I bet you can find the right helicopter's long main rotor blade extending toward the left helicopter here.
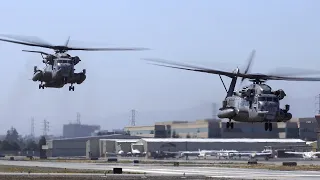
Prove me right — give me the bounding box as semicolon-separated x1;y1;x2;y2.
143;58;235;77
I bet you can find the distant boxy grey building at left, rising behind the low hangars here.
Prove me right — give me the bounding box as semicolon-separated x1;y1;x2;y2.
63;124;100;138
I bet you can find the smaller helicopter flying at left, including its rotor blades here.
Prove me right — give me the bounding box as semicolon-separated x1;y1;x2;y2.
0;34;147;91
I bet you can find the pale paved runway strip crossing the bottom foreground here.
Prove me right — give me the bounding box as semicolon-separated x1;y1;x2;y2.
0;160;320;180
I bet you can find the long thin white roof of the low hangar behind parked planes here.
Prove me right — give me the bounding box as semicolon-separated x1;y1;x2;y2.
142;138;305;143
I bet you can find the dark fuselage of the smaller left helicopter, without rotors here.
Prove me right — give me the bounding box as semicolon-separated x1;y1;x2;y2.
32;54;86;88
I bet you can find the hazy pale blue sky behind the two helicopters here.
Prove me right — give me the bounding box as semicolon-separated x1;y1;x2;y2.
0;0;320;135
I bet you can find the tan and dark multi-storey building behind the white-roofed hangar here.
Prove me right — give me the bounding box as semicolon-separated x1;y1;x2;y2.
125;117;317;141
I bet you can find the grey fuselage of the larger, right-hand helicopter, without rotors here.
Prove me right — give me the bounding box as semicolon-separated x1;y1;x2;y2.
218;84;292;123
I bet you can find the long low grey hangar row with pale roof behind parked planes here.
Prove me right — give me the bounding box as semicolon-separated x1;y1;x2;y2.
47;135;312;158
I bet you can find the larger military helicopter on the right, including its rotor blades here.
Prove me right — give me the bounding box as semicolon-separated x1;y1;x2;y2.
143;50;320;131
